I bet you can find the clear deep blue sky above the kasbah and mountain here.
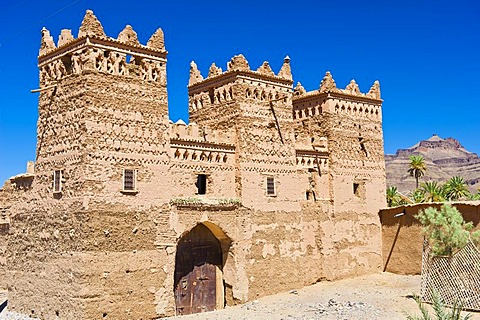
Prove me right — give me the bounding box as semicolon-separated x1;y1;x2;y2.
0;0;480;184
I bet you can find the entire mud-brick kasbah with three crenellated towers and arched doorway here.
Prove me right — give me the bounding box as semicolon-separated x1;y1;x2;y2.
0;10;385;319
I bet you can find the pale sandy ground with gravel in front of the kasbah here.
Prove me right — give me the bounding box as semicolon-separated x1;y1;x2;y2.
160;273;480;320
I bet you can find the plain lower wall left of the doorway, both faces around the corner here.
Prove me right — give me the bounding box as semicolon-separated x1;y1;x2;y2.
2;193;166;319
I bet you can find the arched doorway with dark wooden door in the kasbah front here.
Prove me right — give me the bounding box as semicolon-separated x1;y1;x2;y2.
174;224;230;315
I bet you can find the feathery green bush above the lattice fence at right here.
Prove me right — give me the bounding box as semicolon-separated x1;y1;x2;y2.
415;204;480;256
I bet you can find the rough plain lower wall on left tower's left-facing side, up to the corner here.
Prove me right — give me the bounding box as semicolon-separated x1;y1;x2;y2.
6;192;83;318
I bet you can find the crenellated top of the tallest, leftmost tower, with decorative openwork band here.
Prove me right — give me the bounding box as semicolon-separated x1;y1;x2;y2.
38;10;167;88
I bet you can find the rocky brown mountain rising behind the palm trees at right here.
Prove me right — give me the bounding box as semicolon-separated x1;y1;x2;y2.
385;134;480;193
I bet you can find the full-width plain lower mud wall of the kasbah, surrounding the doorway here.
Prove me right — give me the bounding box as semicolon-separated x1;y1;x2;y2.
1;186;380;319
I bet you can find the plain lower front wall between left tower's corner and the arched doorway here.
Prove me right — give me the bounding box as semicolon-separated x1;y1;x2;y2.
79;201;173;319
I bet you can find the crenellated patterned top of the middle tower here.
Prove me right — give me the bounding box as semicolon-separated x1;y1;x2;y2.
188;54;293;129
